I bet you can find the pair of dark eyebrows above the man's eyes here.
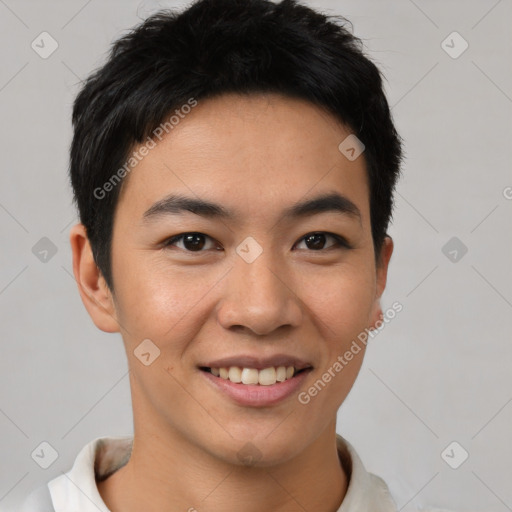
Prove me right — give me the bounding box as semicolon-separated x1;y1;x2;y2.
143;192;362;224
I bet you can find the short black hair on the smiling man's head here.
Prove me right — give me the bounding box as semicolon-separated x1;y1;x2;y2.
69;0;402;290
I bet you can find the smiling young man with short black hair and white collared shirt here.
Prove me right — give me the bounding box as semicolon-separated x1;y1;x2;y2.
20;0;402;512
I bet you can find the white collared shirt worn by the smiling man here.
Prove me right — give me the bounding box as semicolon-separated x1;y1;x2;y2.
19;435;397;512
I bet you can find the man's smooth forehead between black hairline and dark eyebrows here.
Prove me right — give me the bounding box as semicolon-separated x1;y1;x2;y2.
118;94;369;224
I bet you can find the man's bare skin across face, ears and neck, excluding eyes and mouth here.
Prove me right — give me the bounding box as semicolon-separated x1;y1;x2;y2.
70;94;393;512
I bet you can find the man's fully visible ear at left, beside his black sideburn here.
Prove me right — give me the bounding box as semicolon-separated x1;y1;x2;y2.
69;224;119;332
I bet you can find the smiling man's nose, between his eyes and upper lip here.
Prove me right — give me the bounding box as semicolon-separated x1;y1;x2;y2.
217;251;303;336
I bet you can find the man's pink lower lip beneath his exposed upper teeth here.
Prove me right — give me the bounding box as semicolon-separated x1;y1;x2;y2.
199;369;311;407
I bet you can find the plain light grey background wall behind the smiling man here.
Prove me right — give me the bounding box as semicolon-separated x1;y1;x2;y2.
0;0;512;512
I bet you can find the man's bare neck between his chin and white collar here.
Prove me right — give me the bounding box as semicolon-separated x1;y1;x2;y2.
98;408;348;512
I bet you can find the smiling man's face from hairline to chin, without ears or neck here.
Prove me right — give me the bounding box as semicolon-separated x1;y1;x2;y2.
80;95;391;464
